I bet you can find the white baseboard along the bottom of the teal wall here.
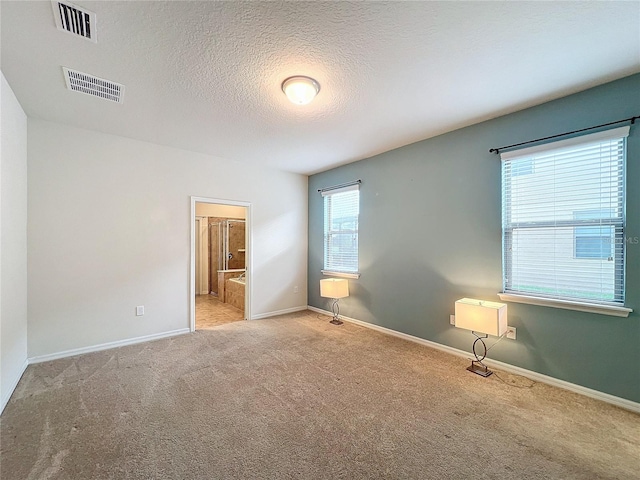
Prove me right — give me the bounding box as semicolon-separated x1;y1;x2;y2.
309;306;640;413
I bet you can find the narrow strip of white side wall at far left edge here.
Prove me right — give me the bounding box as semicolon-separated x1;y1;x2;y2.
0;74;27;412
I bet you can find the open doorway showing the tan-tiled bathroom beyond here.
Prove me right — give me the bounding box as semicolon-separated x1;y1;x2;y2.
190;197;251;331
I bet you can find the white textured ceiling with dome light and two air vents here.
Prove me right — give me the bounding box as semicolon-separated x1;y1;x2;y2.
0;0;640;174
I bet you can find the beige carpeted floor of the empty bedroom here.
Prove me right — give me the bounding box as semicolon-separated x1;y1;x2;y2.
0;312;640;480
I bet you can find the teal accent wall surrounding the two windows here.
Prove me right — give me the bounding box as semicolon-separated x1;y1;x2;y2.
308;74;640;402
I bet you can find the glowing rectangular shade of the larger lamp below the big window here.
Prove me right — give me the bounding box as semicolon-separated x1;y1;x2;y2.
456;298;507;337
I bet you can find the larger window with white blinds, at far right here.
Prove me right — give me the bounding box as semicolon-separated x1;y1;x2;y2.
501;127;629;305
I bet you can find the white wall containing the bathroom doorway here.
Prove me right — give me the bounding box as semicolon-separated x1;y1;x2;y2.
28;119;307;357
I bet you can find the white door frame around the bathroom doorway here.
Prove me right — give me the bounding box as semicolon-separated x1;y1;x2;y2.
189;196;253;332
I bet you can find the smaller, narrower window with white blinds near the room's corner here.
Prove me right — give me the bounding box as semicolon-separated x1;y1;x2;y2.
321;184;360;275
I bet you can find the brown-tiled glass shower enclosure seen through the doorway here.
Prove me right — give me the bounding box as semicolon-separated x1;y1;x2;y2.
209;217;246;295
